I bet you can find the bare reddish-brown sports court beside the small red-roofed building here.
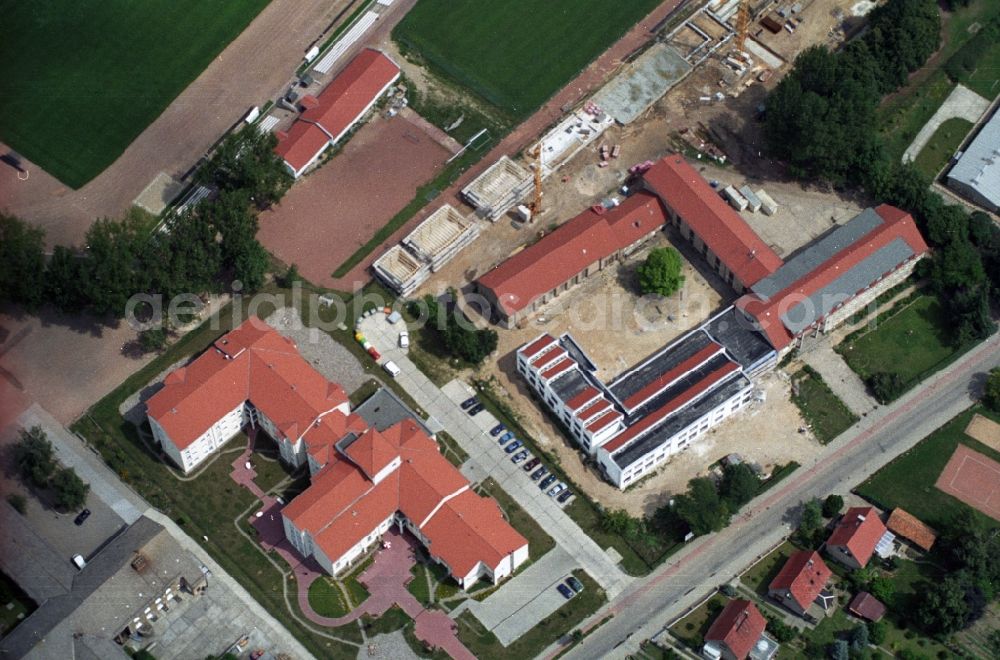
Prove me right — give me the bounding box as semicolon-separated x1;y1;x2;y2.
257;116;451;287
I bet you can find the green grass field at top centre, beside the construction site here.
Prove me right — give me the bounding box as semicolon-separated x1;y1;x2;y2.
393;0;660;118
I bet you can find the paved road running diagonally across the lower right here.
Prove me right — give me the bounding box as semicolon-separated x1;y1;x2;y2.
556;335;1000;658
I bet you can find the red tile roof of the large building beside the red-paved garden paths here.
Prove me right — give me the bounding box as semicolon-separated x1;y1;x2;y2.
282;420;527;577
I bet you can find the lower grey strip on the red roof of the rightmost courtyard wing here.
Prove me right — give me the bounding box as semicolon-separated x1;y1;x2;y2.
781;238;914;335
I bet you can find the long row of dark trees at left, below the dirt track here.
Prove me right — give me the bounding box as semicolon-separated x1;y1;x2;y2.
0;129;292;318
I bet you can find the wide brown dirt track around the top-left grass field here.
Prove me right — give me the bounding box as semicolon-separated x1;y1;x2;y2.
0;0;360;247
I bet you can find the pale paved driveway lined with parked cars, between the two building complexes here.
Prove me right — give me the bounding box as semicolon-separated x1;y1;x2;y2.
361;314;632;598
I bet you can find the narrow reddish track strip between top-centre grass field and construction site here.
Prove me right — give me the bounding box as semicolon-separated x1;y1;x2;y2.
329;0;688;291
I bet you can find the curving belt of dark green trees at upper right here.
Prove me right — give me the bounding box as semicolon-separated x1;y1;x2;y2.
764;0;1000;348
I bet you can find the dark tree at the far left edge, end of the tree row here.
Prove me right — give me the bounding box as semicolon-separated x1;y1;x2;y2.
0;213;45;310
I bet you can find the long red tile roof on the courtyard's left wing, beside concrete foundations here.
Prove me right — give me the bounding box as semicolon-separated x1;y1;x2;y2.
479;193;666;314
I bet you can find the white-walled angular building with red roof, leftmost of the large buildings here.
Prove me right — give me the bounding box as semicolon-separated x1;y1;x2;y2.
146;318;356;473
